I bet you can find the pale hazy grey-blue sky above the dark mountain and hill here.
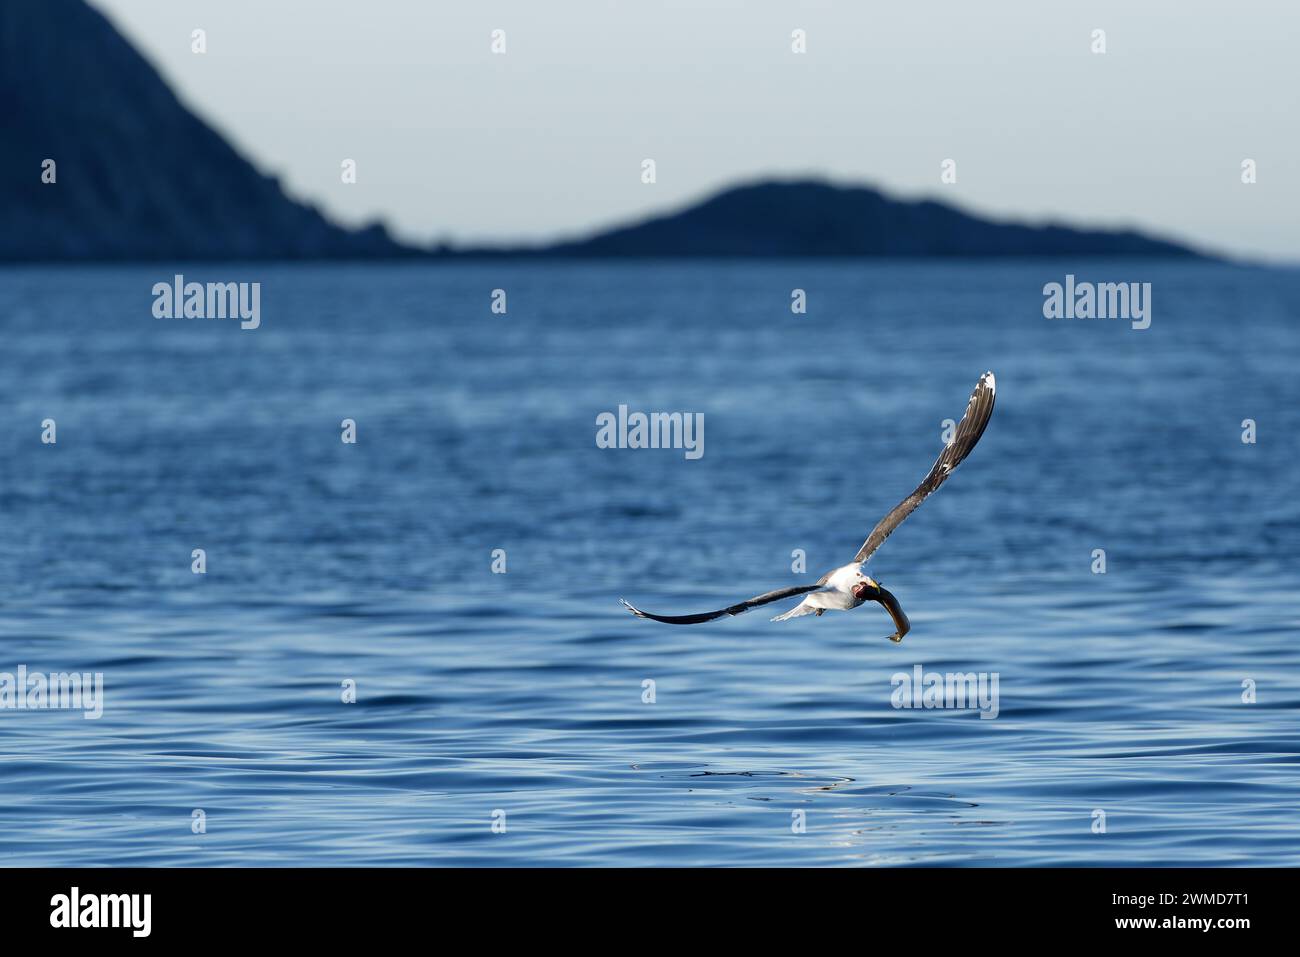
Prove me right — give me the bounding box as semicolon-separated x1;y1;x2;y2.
94;0;1300;260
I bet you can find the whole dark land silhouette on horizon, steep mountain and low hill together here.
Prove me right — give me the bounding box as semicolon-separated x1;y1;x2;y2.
0;0;1204;263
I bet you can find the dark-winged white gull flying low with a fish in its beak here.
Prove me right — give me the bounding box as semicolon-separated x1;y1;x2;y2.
619;372;997;641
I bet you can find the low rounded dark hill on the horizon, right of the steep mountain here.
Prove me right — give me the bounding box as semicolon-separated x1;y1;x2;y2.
483;181;1201;259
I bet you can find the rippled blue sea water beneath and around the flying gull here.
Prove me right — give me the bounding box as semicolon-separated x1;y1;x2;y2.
0;261;1300;866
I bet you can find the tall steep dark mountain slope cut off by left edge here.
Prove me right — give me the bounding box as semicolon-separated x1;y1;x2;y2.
0;0;408;260
